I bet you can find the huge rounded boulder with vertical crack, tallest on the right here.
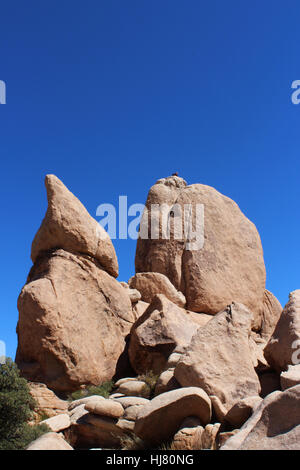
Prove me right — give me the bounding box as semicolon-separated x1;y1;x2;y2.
135;176;266;330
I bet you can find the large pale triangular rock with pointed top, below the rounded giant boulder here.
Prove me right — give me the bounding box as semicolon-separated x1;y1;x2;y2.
175;302;260;414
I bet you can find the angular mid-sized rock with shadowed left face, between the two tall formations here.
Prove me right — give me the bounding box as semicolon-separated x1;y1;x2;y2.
128;294;209;374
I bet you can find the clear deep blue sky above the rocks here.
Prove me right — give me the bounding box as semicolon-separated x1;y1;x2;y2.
0;0;300;357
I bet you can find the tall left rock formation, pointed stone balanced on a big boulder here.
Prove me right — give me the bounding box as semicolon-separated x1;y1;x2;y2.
16;176;135;392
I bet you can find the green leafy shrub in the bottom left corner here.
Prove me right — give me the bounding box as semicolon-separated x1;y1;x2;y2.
0;359;50;450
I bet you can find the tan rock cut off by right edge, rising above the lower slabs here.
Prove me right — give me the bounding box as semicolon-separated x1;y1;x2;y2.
264;289;300;372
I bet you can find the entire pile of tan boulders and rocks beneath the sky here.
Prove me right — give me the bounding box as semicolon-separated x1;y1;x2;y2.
16;176;300;449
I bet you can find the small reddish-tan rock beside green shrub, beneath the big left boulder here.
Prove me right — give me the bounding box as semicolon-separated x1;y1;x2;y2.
28;382;68;420
